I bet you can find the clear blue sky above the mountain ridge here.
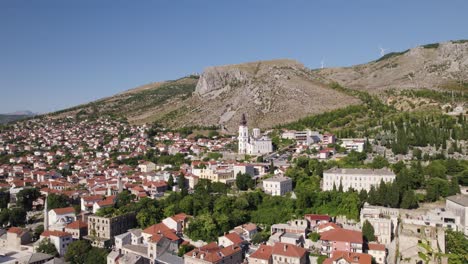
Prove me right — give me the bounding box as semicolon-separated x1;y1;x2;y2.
0;0;468;113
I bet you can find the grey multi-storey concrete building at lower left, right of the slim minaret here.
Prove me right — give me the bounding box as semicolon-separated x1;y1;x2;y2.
86;212;136;247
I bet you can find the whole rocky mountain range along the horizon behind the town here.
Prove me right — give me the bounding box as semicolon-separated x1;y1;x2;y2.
44;40;468;132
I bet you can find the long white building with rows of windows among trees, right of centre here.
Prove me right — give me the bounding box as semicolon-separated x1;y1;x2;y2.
322;168;396;192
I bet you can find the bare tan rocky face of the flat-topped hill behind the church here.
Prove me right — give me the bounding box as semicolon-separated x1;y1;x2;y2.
174;60;359;132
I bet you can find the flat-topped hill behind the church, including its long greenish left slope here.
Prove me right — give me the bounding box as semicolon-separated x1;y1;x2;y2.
49;60;360;132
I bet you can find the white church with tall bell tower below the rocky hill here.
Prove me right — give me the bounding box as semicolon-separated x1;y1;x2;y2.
238;114;273;155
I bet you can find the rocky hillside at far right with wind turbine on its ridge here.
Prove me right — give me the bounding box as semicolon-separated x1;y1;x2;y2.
317;40;468;94
